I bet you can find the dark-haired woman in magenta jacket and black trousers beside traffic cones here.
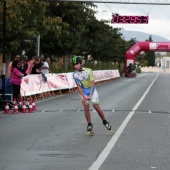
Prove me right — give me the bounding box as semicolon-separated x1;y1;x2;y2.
11;61;24;101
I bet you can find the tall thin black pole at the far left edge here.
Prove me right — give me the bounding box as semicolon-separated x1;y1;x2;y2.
1;0;6;100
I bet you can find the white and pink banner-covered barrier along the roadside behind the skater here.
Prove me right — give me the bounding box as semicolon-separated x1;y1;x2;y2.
18;70;120;98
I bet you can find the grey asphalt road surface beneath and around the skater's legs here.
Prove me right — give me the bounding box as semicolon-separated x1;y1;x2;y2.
0;73;170;170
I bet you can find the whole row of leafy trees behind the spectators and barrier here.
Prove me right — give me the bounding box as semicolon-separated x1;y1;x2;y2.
0;0;135;69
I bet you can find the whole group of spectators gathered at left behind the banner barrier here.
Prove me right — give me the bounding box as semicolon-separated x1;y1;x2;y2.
7;54;51;101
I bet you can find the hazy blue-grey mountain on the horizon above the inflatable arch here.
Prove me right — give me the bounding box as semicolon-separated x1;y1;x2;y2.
120;30;170;42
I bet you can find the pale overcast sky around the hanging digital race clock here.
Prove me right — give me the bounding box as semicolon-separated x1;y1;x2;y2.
95;3;170;40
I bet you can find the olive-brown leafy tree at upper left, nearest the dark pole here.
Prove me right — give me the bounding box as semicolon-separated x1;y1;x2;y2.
0;0;62;53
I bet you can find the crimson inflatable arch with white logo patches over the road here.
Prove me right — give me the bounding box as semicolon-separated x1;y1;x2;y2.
125;42;170;75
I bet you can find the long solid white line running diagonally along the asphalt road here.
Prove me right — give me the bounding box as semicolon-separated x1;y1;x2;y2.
88;74;159;170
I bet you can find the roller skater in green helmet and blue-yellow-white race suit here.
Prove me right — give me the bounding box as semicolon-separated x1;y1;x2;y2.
72;56;113;136
